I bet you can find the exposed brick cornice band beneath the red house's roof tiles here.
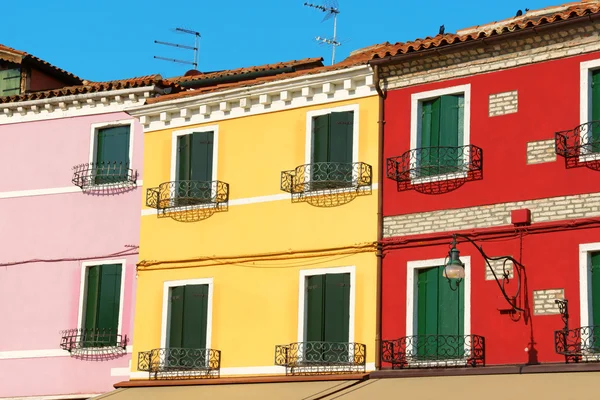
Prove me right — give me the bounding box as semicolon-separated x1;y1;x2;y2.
382;21;600;89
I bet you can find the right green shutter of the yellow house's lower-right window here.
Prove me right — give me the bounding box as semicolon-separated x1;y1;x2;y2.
323;274;350;343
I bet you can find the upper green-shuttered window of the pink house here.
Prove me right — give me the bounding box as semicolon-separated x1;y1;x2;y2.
91;121;133;185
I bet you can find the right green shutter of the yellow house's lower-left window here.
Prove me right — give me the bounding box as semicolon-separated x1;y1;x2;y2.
181;285;208;349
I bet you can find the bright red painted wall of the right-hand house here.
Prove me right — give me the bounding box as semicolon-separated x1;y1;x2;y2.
382;52;600;367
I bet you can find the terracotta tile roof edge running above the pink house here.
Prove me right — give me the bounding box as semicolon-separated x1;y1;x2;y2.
0;75;181;104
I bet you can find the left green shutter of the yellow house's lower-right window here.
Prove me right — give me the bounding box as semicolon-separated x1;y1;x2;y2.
306;275;325;342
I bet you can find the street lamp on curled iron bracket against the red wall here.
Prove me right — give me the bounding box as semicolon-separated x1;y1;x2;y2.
443;233;525;312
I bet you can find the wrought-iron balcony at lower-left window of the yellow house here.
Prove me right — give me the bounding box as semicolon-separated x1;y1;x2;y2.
138;347;221;379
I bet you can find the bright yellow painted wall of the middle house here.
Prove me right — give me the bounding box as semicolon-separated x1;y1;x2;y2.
132;97;378;375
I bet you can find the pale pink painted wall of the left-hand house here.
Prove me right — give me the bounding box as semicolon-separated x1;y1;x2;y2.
0;113;143;398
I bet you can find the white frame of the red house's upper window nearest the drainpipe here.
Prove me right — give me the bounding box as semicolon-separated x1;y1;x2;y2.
410;83;471;185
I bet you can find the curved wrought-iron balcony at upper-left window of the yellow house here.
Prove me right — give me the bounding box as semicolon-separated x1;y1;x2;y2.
146;181;229;222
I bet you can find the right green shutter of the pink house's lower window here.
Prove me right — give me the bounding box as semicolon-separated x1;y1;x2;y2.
96;264;121;334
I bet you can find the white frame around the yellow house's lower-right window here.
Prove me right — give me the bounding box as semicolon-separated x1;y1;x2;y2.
296;265;356;344
